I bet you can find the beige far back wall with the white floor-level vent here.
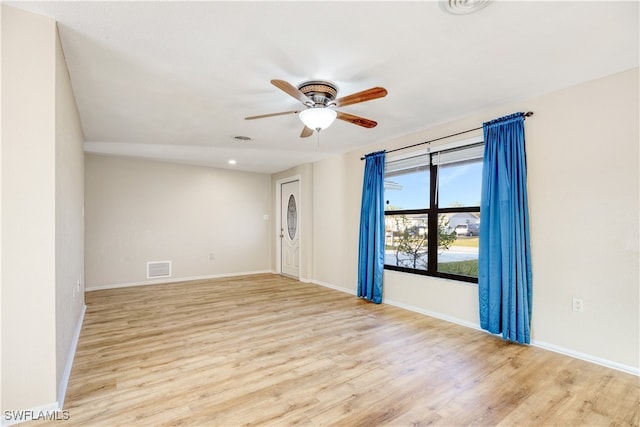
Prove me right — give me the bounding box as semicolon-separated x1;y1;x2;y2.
85;154;272;289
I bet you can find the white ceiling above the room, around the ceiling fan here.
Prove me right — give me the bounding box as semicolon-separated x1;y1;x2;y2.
5;1;639;173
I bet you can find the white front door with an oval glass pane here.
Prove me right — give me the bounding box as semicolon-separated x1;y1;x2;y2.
280;181;300;278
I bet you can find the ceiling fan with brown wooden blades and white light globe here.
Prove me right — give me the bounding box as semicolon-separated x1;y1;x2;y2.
245;79;387;138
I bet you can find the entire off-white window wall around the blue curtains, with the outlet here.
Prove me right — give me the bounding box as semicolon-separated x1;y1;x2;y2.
313;69;640;373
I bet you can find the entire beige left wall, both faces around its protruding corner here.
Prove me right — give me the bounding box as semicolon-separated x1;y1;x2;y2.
1;5;83;410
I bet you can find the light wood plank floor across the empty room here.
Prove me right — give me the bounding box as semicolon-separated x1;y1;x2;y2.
34;274;640;426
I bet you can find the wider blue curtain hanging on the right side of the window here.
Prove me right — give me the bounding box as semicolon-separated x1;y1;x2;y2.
478;113;531;344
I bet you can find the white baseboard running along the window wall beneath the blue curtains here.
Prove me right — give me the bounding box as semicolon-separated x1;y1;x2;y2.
309;280;640;376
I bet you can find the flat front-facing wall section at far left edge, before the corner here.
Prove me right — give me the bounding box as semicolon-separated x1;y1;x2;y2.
2;5;56;410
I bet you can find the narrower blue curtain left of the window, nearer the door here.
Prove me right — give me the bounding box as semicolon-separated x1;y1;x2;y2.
358;151;385;304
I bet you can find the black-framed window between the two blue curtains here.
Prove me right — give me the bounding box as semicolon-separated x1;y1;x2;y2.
384;140;483;283
